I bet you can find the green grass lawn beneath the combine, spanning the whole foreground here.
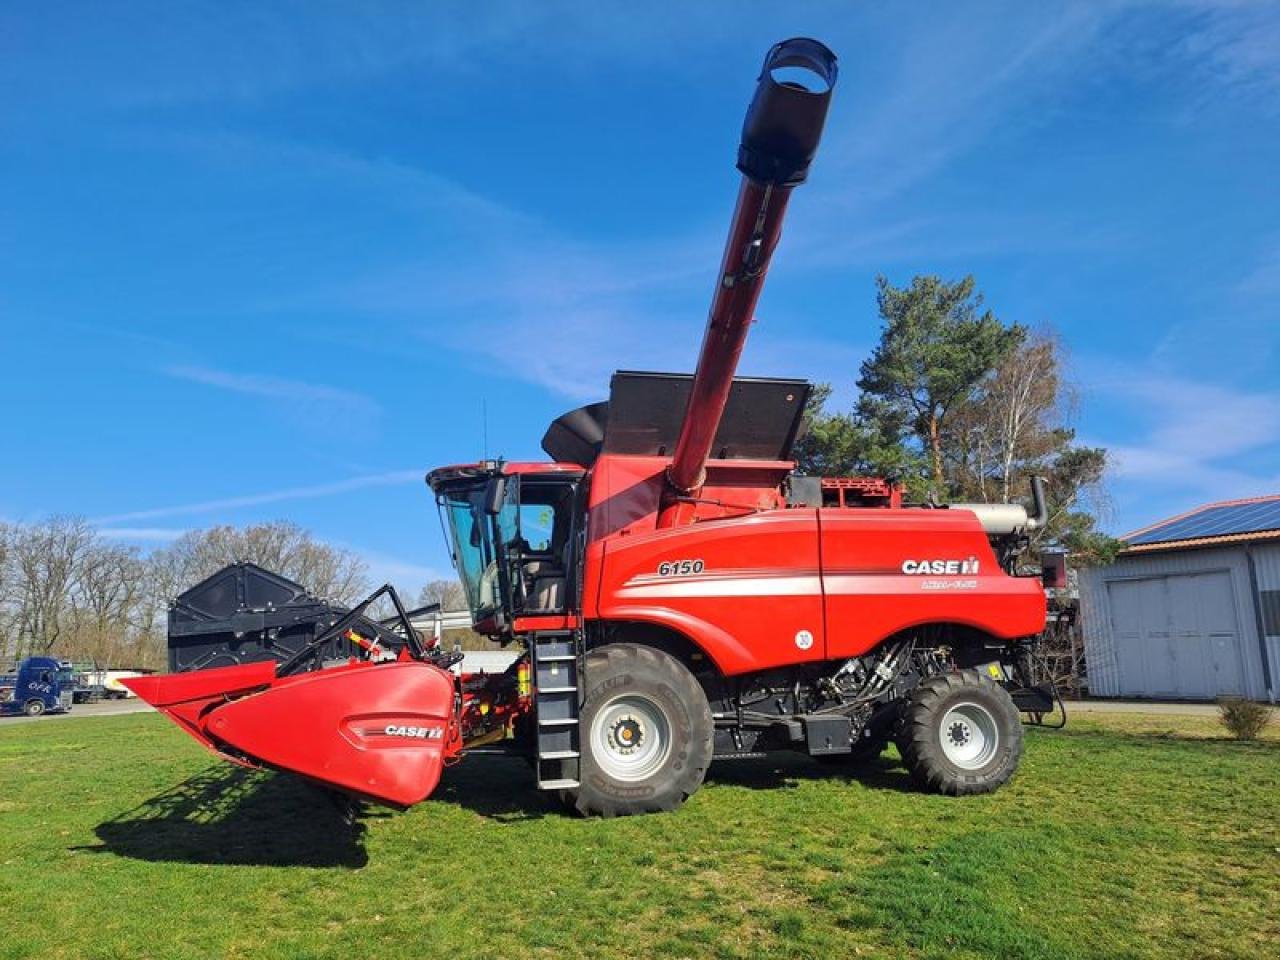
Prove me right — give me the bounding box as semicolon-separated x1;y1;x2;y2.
0;714;1280;960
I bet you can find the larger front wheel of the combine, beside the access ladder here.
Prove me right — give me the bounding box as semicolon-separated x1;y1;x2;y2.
561;644;716;817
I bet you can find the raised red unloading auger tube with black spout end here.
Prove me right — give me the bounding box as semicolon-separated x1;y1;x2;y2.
658;37;837;527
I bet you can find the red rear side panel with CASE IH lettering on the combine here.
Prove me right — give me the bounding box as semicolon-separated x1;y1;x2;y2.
818;509;1044;659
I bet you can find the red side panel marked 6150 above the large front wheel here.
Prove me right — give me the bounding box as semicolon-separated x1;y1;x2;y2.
593;509;827;675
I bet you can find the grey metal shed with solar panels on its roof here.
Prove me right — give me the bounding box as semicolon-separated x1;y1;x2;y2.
1080;494;1280;703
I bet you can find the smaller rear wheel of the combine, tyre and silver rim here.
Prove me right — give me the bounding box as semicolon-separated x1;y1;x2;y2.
896;669;1023;796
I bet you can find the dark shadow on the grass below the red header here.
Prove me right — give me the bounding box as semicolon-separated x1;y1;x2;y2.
78;763;378;869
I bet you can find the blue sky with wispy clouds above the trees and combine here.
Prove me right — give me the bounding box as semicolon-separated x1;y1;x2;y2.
0;0;1280;586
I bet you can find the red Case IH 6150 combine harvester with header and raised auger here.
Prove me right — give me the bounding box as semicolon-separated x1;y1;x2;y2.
125;38;1052;817
